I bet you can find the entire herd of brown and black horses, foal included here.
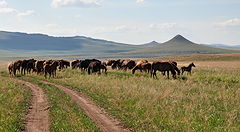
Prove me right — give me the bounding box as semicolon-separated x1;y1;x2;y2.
8;59;195;79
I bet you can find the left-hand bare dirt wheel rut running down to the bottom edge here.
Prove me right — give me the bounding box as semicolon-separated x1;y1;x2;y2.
16;79;49;132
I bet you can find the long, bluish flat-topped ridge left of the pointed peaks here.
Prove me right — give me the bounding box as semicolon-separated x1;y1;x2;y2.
0;31;157;55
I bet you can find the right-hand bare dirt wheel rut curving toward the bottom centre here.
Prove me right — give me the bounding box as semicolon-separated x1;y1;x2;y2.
42;81;129;132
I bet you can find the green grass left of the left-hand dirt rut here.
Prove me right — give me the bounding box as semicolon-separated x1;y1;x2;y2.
0;75;31;132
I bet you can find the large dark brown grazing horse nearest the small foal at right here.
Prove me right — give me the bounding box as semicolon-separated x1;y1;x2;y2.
151;62;176;79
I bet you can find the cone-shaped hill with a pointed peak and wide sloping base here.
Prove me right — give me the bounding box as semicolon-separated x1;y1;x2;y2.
120;35;238;57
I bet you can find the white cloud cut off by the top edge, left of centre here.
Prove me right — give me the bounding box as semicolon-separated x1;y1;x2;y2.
52;0;100;8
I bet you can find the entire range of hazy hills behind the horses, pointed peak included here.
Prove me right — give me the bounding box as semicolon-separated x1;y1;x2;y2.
0;31;236;57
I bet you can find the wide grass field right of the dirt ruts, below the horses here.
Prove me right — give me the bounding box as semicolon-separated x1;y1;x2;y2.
0;54;240;132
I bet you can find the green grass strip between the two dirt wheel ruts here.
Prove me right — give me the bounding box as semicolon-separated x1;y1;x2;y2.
18;77;100;132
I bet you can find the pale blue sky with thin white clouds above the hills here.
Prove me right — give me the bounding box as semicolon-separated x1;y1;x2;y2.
0;0;240;45
